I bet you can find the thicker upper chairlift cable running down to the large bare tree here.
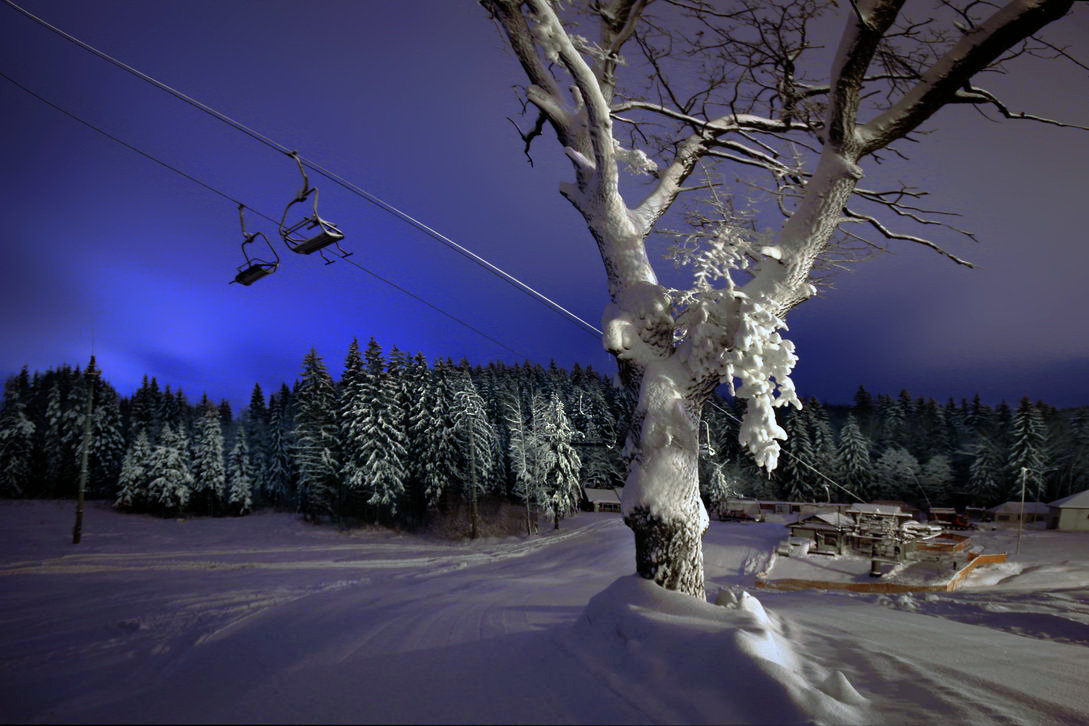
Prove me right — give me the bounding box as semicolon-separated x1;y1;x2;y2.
2;0;602;335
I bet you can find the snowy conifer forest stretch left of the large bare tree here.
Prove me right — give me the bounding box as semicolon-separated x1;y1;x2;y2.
0;340;632;533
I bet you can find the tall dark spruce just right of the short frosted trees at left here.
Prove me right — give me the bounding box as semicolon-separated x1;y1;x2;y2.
294;348;340;521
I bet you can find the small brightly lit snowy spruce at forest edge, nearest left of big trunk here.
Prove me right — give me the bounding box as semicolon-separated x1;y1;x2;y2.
536;392;583;529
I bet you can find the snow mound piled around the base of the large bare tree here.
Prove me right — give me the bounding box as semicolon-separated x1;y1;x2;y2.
566;575;872;724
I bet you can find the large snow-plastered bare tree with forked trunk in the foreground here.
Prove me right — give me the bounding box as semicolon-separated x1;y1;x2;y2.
482;0;1072;598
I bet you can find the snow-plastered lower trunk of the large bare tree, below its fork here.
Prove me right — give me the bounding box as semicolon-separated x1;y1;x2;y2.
623;364;709;599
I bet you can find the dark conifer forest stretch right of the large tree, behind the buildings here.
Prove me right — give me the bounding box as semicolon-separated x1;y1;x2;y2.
701;386;1089;507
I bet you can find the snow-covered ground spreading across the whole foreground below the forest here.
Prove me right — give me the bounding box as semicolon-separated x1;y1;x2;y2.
0;502;1089;724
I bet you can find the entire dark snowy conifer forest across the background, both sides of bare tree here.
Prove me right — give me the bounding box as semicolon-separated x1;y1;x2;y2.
0;340;1089;533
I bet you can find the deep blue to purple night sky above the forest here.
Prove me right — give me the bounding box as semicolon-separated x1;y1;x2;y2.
0;0;1089;407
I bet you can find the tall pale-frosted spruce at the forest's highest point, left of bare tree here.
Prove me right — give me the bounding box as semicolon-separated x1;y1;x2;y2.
355;339;407;521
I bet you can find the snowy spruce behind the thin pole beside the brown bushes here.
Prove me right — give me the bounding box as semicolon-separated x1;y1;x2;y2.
452;373;495;539
